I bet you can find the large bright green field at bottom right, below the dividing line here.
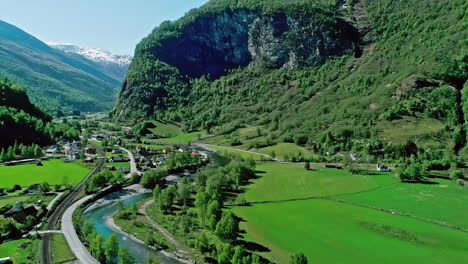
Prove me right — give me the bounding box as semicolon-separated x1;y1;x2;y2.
234;200;468;264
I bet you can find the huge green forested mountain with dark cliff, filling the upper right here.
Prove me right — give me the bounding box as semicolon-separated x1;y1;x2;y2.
112;0;468;157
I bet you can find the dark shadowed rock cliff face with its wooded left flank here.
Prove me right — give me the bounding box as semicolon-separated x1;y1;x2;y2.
114;5;359;120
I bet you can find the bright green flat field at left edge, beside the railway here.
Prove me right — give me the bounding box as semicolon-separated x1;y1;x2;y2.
0;159;90;188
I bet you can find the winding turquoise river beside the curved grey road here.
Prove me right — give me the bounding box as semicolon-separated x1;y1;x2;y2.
85;189;182;264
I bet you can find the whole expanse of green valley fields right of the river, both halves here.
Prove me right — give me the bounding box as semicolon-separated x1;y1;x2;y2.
232;163;468;263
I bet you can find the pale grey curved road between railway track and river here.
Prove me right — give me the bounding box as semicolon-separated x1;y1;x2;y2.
59;145;139;264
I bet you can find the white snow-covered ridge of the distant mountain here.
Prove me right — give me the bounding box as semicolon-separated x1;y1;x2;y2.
47;43;132;66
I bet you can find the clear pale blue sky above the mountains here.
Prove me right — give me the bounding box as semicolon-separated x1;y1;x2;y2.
0;0;208;56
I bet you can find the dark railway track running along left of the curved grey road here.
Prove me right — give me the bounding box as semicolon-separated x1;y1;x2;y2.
39;145;105;264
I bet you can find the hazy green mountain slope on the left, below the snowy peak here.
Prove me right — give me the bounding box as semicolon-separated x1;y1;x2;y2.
0;21;122;111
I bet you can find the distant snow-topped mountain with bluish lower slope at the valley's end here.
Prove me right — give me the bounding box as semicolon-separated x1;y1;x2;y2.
47;43;132;80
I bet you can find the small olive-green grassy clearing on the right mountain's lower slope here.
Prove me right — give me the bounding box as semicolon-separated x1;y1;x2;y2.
376;117;444;144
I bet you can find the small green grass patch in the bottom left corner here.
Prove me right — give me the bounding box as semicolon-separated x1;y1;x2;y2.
0;239;39;264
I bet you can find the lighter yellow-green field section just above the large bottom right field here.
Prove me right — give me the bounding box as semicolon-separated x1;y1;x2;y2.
245;162;397;202
